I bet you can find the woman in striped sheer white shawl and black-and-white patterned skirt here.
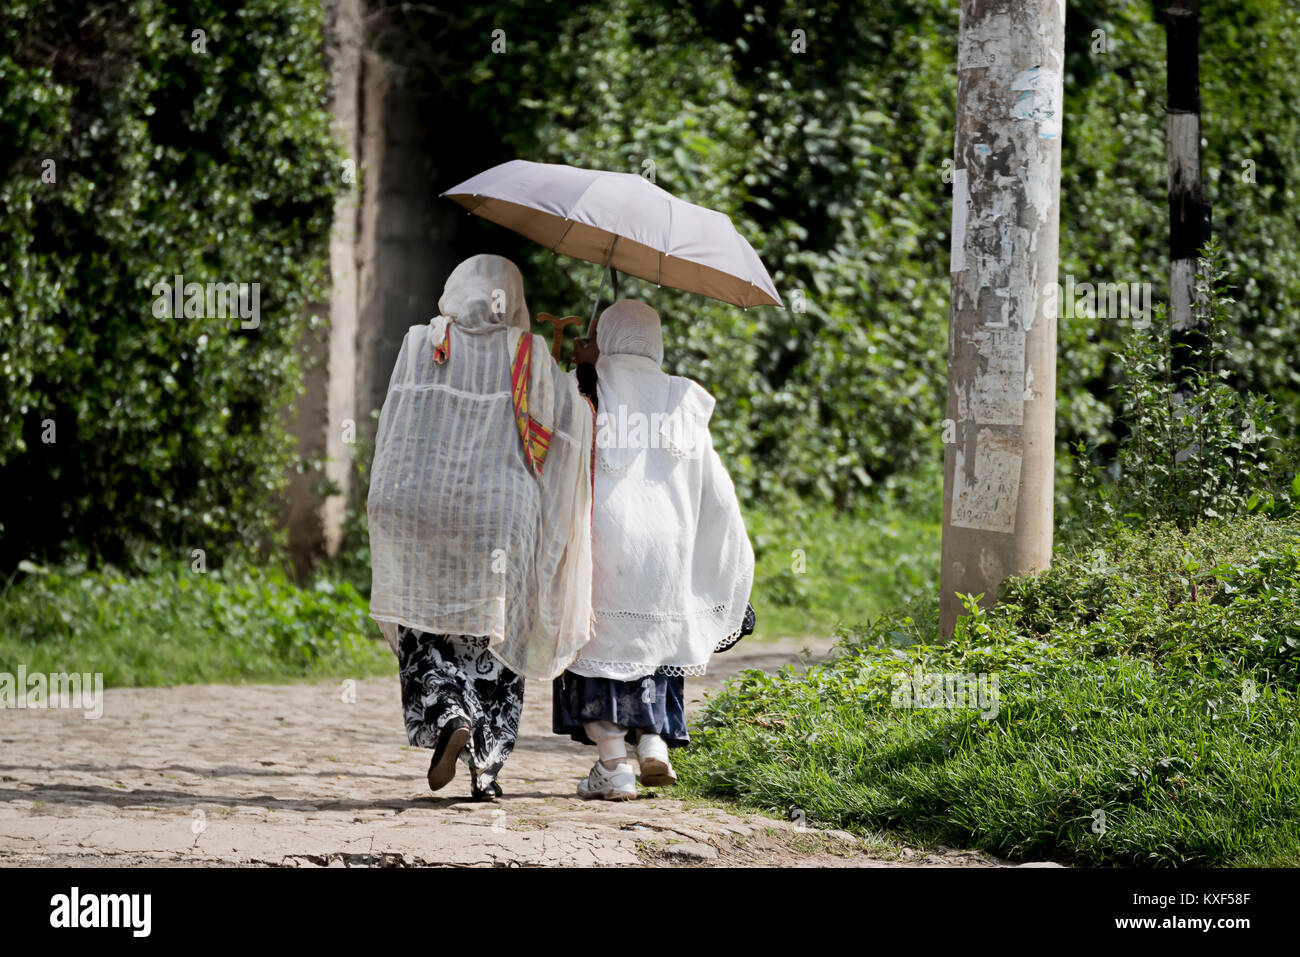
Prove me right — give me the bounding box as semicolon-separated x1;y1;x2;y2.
368;256;593;798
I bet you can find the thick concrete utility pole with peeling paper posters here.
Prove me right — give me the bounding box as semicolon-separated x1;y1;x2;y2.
940;0;1065;636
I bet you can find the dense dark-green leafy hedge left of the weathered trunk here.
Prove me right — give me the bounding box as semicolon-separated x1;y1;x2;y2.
0;0;342;568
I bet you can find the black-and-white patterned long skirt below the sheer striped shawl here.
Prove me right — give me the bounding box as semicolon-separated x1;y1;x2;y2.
398;627;524;791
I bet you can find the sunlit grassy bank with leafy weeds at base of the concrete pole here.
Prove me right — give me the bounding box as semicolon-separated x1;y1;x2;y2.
675;518;1300;866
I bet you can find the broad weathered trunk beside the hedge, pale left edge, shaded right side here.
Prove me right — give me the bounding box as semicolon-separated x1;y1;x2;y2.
286;0;464;572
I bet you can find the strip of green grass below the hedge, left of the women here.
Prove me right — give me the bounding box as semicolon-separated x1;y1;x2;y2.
0;558;393;685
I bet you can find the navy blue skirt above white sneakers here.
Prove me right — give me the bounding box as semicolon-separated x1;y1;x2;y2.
551;671;690;748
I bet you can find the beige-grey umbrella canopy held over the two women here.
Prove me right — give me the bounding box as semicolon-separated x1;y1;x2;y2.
442;160;781;308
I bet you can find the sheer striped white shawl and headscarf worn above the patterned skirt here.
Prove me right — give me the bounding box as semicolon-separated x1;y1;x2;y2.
368;256;593;679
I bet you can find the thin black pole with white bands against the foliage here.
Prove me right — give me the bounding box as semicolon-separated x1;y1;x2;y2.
1165;0;1210;385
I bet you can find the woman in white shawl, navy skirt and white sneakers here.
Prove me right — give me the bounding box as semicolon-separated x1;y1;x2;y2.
553;299;754;800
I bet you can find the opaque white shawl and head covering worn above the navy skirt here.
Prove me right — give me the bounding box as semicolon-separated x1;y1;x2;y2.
569;300;754;680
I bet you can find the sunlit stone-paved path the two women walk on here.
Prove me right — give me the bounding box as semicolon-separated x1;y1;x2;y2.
0;641;998;867
